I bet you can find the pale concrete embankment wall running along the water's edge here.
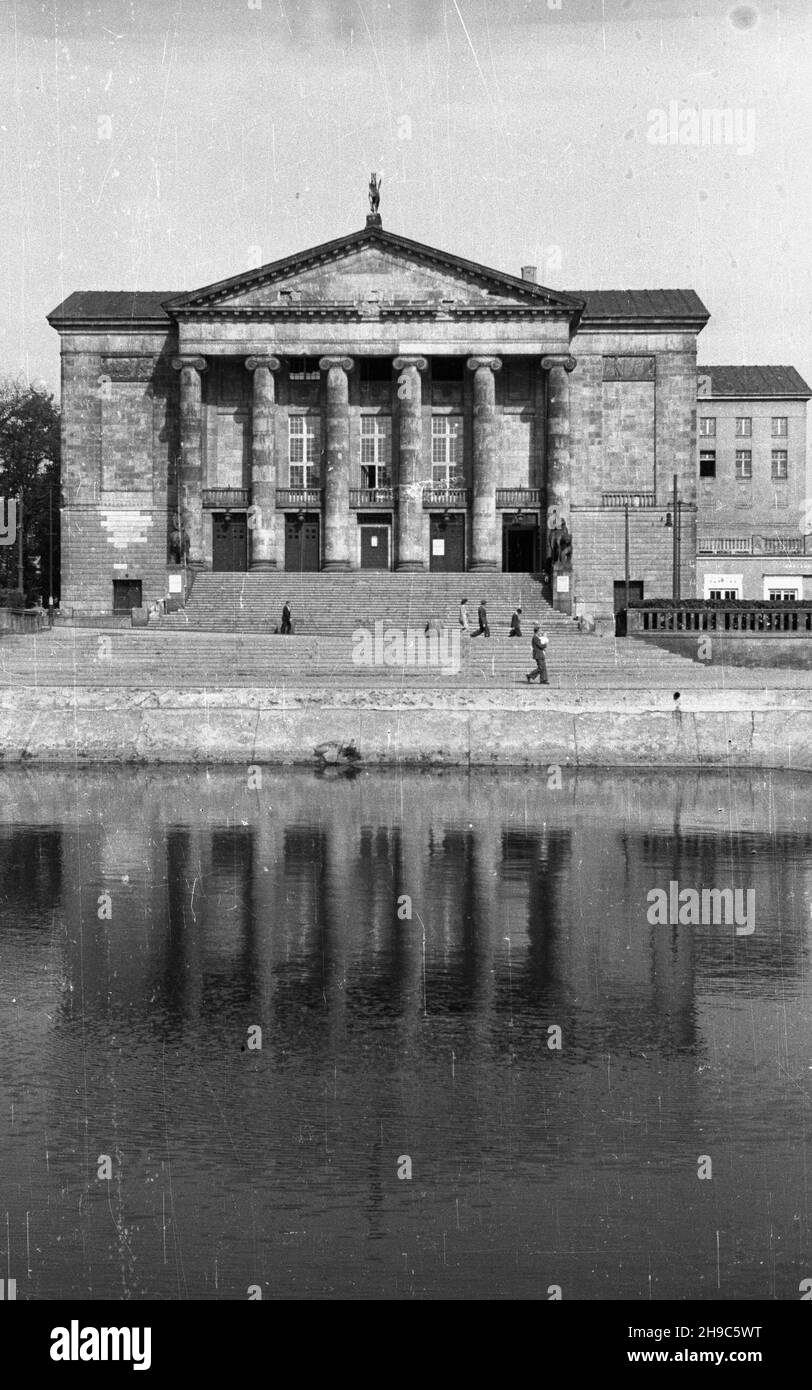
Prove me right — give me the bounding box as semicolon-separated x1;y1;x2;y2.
6;681;812;771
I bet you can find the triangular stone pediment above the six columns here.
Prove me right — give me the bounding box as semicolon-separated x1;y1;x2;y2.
165;227;583;318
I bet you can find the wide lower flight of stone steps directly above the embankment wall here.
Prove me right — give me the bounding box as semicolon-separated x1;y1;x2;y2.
0;623;784;692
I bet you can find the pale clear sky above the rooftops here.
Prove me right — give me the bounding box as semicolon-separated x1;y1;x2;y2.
0;0;812;403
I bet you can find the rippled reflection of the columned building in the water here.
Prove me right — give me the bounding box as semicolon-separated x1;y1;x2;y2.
0;771;812;1048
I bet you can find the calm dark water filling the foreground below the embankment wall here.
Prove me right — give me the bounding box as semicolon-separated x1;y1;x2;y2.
0;767;812;1300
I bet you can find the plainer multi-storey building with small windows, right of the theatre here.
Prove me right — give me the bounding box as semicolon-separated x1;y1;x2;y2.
697;367;812;599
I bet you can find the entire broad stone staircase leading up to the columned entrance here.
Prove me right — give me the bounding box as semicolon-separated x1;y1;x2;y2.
6;571;804;691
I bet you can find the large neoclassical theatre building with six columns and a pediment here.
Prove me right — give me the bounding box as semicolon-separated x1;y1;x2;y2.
49;213;709;614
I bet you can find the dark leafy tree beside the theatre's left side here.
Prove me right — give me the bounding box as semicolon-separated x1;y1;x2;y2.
0;378;61;605
